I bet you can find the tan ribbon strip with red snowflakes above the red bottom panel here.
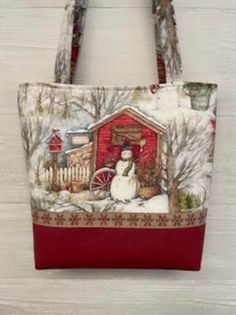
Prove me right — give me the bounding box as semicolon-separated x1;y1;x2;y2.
32;210;207;229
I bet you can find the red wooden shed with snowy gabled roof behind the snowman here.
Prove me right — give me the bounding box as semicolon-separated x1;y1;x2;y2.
89;106;165;171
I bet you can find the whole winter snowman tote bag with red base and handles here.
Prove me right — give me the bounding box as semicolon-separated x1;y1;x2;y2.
18;0;217;270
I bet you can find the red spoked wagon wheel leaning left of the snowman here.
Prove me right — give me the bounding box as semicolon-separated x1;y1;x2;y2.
89;167;116;199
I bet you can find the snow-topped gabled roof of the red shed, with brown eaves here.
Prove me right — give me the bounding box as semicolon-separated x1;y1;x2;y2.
88;106;166;135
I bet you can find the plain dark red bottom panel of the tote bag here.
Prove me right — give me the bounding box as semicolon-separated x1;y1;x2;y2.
33;224;205;270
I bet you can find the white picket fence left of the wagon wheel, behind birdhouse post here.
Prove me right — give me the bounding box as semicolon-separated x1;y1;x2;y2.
43;166;91;184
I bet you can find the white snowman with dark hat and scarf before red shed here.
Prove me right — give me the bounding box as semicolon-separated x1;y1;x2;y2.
111;146;138;202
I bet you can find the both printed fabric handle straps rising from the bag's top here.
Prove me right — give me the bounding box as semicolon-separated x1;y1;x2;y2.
55;0;182;84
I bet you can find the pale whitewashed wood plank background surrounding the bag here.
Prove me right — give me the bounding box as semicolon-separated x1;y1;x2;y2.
0;0;236;315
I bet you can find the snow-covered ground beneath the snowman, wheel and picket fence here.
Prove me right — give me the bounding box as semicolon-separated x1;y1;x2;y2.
32;189;169;213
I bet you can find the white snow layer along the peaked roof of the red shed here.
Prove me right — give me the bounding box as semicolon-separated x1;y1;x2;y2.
88;105;166;133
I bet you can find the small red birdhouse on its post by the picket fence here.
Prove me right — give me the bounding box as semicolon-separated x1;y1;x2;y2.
47;129;64;191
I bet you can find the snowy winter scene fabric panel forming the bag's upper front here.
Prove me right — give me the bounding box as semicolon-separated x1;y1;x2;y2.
19;84;216;213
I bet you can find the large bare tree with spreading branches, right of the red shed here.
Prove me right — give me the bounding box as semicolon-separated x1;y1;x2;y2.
163;113;211;212
